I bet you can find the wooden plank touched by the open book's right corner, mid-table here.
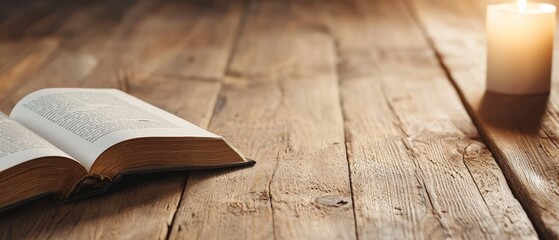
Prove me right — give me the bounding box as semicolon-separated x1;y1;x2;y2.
171;1;356;239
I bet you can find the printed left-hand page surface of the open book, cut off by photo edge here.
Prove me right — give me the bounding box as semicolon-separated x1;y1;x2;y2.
0;112;75;172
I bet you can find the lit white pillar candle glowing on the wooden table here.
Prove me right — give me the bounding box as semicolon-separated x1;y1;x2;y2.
486;1;555;94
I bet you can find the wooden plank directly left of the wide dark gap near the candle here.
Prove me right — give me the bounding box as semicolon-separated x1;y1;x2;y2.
324;0;537;239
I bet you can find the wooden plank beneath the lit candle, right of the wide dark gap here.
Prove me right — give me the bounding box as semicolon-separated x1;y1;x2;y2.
414;0;559;239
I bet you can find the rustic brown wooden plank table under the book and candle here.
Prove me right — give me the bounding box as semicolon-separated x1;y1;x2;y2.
0;0;559;239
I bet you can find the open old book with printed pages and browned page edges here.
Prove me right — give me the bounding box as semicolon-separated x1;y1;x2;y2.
0;88;254;209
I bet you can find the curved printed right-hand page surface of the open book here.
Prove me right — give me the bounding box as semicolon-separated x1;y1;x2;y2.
11;88;221;171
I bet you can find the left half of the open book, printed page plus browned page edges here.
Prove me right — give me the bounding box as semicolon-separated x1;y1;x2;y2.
0;113;87;211
